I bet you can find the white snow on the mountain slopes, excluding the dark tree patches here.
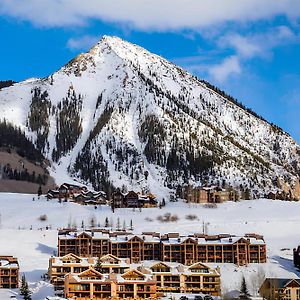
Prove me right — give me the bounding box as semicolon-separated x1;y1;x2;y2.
0;36;300;198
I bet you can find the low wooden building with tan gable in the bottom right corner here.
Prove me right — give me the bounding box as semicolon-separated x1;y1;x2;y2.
259;278;300;300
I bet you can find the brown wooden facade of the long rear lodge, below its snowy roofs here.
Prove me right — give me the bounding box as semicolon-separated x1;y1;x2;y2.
58;235;266;265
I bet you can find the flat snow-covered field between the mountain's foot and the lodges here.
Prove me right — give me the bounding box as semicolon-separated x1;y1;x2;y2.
0;193;300;300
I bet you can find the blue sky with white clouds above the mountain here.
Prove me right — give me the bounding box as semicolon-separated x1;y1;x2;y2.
0;0;300;142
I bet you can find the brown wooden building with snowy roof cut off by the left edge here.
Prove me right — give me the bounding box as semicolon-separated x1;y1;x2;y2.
0;256;19;289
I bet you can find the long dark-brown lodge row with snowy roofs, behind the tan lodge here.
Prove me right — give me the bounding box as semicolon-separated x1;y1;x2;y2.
58;230;266;265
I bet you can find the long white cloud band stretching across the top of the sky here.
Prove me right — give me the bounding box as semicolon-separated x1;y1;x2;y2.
0;0;300;31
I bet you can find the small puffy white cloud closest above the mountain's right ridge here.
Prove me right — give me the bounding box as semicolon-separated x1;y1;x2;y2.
208;56;241;82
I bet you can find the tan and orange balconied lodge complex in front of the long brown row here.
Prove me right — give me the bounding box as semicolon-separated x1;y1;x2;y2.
48;254;220;299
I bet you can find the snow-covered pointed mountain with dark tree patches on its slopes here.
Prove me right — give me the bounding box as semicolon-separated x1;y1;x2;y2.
0;36;300;198
